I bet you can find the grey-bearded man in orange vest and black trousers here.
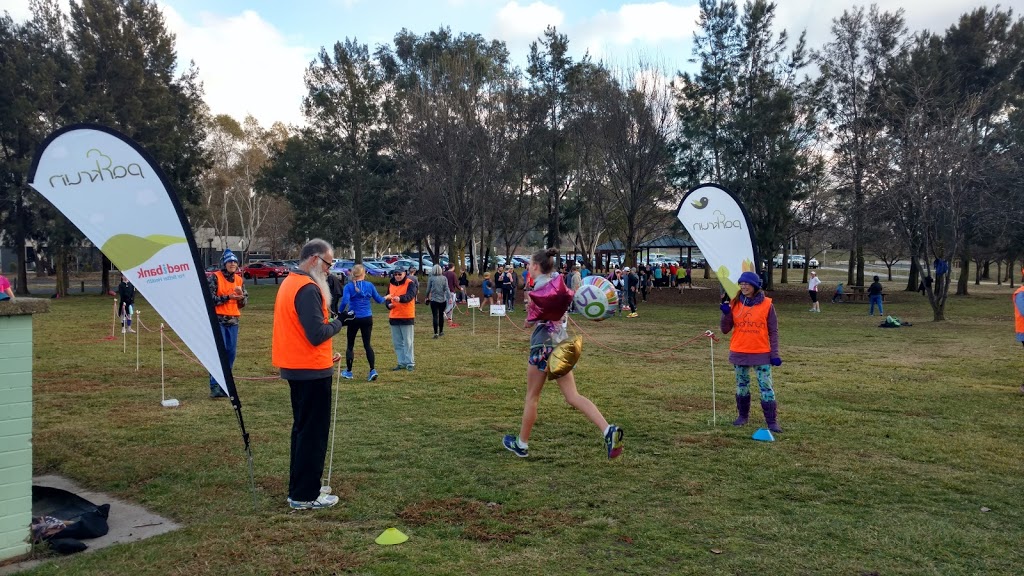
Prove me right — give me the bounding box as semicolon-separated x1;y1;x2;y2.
271;238;341;509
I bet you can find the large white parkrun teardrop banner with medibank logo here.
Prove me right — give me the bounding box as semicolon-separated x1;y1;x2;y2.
29;124;252;494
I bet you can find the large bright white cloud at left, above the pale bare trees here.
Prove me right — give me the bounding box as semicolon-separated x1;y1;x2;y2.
157;0;316;127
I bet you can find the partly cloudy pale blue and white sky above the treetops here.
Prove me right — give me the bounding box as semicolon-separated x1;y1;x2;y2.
0;0;991;126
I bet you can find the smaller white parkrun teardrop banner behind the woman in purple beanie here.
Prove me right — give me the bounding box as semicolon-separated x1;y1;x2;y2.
677;183;761;298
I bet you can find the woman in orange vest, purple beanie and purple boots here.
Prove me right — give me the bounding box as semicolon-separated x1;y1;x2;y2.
721;272;782;433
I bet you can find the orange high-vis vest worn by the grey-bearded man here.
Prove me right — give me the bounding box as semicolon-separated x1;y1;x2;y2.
270;274;334;370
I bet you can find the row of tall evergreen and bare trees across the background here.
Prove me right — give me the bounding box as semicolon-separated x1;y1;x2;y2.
0;0;1024;319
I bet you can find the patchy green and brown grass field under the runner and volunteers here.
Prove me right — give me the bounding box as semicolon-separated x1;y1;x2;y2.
16;281;1024;576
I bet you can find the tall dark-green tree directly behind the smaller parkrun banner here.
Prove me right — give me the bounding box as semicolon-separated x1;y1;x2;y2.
675;0;821;286
